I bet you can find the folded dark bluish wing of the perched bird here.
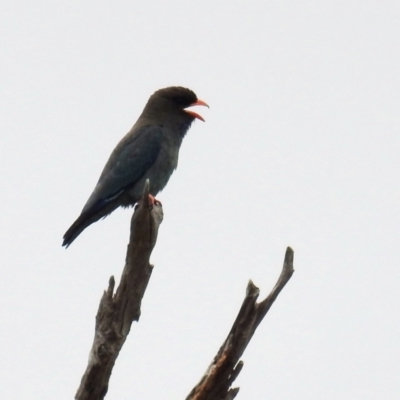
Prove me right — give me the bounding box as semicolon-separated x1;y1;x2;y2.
82;126;163;213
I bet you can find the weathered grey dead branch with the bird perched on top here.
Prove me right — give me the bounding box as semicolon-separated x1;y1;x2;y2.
75;180;163;400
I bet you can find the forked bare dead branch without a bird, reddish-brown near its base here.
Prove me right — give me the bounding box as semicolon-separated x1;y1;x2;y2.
186;247;294;400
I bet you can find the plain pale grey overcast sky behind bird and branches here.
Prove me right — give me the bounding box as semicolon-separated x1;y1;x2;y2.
0;0;400;400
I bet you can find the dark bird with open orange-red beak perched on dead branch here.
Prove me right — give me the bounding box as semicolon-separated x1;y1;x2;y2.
62;86;209;248
